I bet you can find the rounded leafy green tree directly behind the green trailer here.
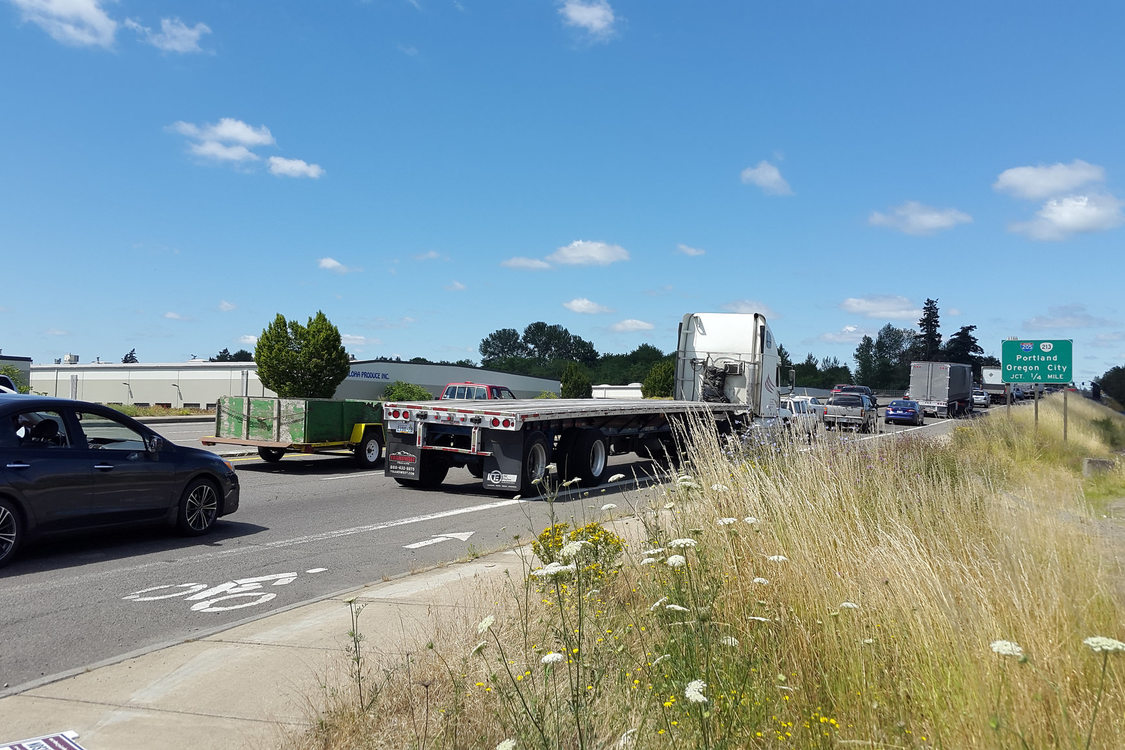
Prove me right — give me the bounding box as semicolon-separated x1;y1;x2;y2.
254;310;351;398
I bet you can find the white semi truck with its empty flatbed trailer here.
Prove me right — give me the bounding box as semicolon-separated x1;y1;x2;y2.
384;313;781;493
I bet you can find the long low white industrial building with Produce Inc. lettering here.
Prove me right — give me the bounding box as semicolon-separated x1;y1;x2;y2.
30;356;559;409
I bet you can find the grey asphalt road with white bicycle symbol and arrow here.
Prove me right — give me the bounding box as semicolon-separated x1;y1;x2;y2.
0;419;967;695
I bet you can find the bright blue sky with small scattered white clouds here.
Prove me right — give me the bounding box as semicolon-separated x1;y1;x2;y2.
0;0;1125;380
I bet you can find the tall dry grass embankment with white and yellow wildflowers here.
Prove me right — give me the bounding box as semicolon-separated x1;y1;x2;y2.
286;397;1125;750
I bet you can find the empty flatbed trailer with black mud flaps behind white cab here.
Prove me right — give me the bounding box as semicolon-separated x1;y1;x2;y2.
384;398;748;493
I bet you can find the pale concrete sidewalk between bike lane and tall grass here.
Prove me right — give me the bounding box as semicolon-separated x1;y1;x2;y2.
0;550;544;750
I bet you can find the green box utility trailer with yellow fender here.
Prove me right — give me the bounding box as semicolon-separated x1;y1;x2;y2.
200;396;384;469
